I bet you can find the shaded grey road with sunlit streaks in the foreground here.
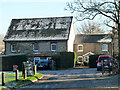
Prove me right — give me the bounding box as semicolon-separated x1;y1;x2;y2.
17;68;119;90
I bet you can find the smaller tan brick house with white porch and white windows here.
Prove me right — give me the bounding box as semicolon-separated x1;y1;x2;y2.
74;34;112;64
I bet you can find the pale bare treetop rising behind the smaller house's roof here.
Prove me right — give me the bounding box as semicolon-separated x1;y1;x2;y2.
78;21;104;34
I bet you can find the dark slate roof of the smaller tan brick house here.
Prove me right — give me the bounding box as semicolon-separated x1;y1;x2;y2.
74;34;112;44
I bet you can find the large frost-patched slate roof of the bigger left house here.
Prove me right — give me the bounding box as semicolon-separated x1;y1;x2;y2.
4;16;73;41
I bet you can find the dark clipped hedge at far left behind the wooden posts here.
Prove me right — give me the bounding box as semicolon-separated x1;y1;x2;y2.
0;54;27;71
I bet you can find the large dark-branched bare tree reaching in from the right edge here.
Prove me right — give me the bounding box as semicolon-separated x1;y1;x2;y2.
66;0;120;72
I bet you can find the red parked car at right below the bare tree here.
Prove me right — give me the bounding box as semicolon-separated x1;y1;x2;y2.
97;55;112;71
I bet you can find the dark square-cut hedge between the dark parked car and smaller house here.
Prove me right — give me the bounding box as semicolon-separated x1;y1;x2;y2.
52;52;75;69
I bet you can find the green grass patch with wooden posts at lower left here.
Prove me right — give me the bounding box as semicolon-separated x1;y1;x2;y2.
0;73;43;89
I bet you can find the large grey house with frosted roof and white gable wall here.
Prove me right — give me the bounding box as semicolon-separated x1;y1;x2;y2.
4;16;75;64
